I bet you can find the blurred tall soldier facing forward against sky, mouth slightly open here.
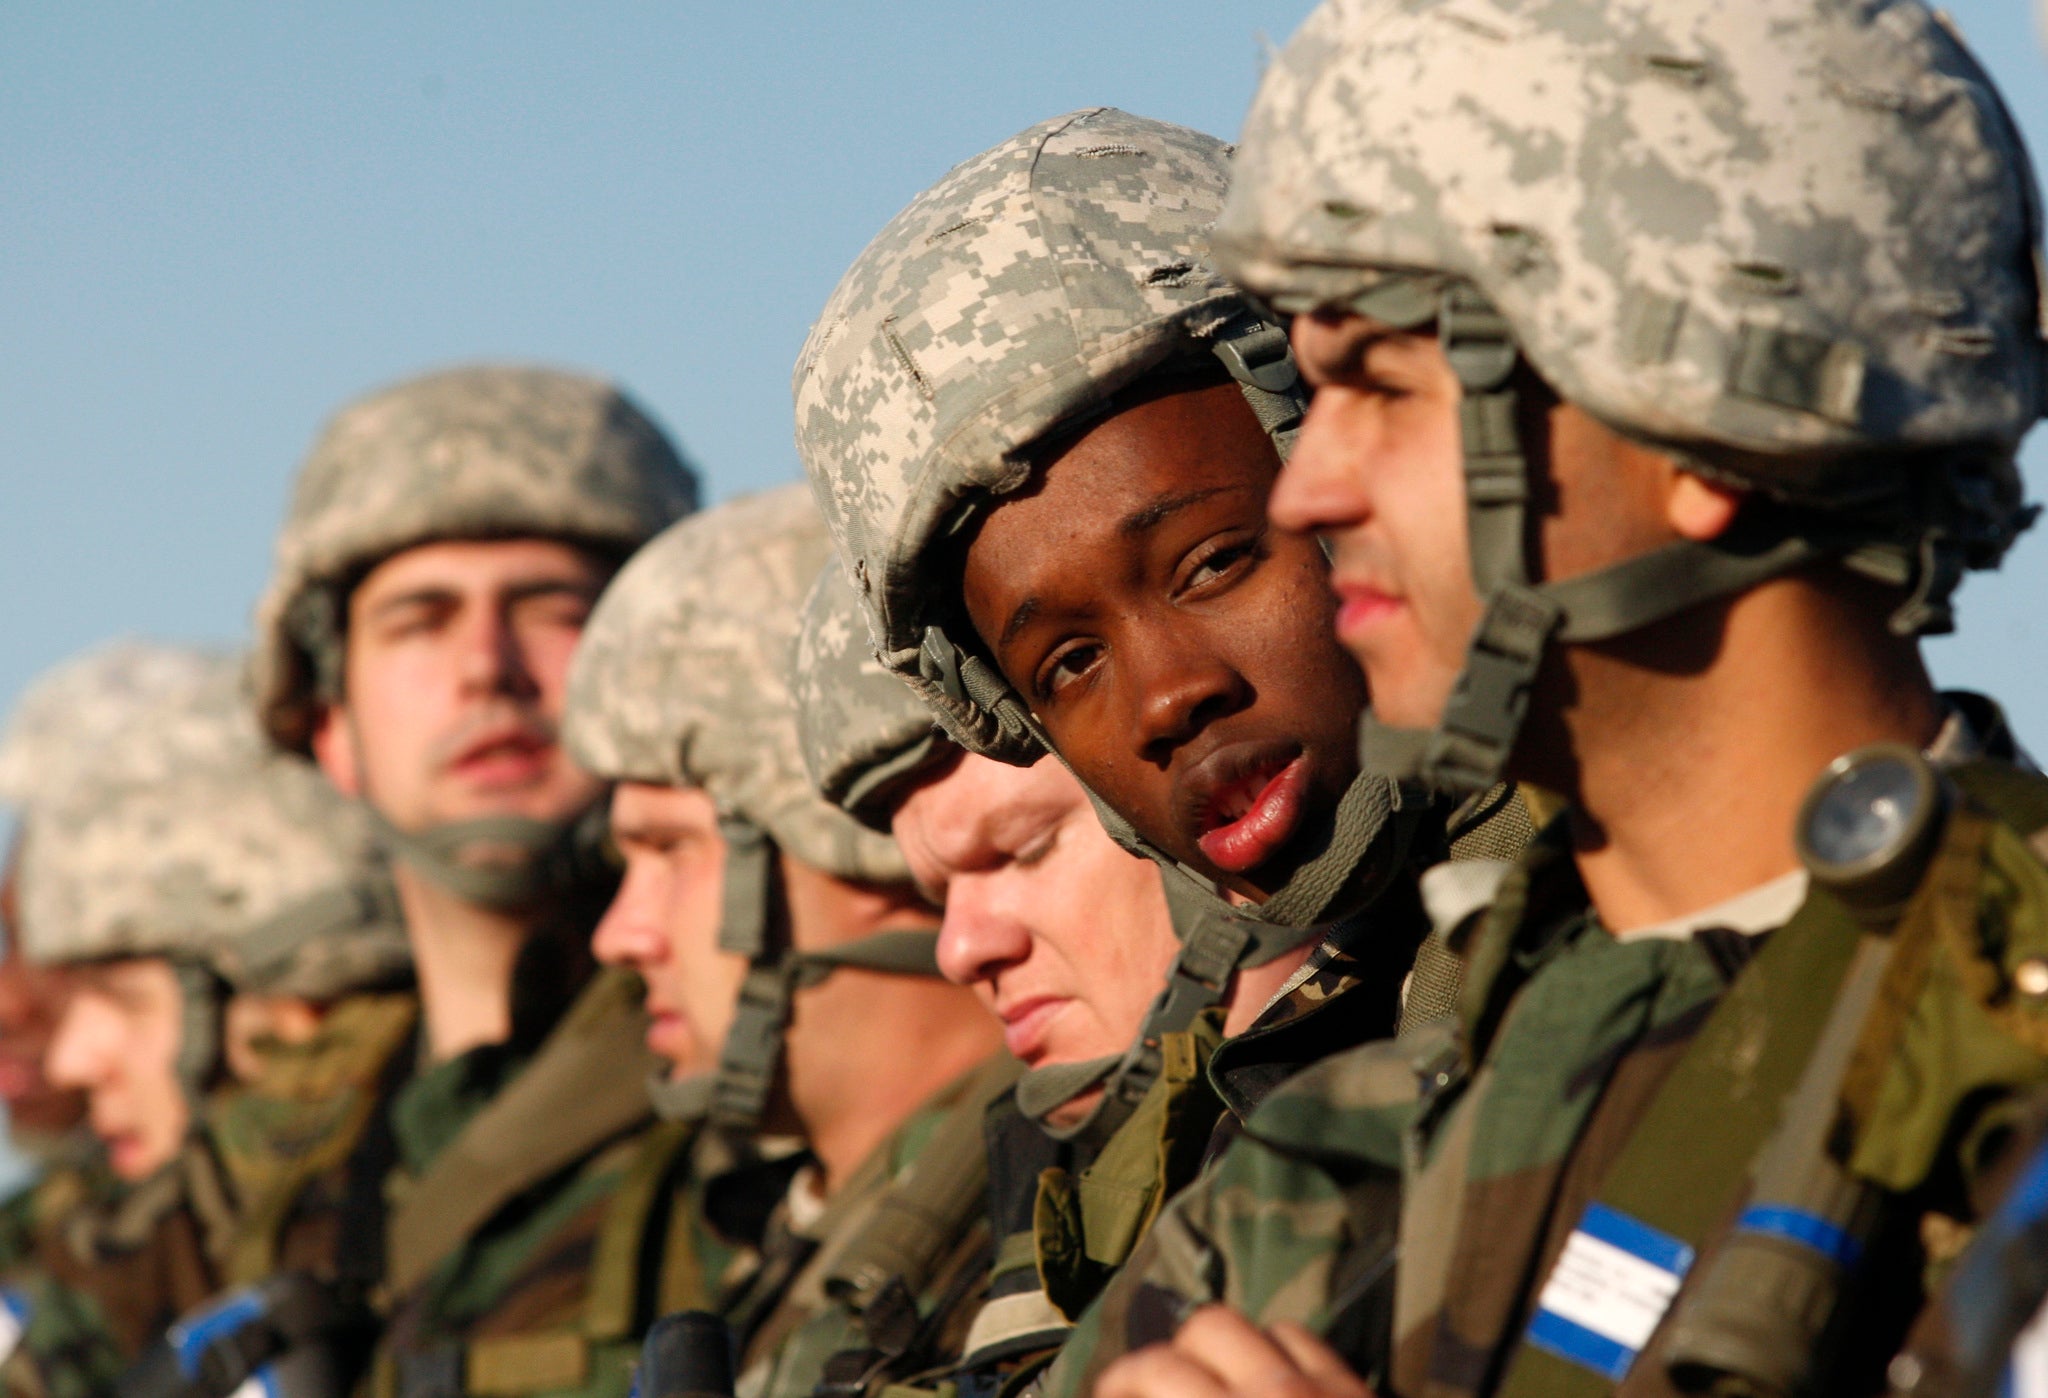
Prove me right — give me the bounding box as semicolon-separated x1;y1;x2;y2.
256;366;696;1396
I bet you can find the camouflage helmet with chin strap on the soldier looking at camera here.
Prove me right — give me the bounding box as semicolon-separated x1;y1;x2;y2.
793;108;1409;949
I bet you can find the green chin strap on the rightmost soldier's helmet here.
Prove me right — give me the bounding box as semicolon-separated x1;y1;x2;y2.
1352;278;1847;796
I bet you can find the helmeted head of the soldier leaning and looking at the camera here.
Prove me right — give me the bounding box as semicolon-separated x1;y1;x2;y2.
795;108;1449;966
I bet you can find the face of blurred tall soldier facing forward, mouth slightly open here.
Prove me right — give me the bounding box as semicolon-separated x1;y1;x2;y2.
313;538;608;843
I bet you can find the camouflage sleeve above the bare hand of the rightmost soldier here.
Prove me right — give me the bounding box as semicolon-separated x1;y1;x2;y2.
1038;1044;1411;1398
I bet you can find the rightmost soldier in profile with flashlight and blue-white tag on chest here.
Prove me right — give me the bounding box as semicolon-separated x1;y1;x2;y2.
1089;0;2048;1398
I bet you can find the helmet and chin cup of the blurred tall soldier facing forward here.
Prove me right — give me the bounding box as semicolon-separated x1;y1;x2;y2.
254;366;696;907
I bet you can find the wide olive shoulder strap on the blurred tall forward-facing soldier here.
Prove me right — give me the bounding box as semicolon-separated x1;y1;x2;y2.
385;972;651;1296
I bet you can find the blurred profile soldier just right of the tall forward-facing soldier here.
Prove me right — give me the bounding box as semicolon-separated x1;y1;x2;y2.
569;487;1016;1394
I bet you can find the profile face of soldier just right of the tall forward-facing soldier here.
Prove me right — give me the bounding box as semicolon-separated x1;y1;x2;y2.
592;782;748;1077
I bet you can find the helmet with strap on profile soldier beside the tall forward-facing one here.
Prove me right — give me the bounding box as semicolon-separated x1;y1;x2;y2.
563;485;936;1128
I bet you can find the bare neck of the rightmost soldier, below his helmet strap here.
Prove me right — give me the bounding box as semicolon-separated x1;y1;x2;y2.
1532;577;1942;931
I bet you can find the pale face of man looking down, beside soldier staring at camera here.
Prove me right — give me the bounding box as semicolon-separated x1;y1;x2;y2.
893;755;1178;1109
